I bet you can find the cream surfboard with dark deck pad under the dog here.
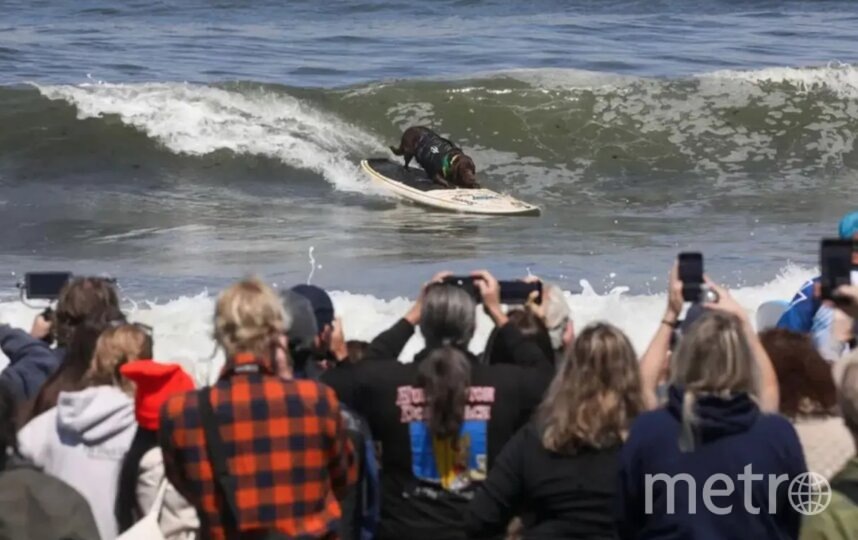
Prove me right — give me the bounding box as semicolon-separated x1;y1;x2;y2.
360;158;540;216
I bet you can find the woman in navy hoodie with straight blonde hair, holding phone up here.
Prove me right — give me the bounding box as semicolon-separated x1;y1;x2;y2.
618;292;807;539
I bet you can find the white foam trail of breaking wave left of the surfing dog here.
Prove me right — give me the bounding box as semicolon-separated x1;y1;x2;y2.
36;83;383;191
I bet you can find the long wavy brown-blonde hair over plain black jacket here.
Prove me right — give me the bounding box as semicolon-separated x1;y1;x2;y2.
537;323;643;454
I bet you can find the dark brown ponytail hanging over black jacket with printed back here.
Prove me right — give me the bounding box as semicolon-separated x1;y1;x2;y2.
417;345;471;444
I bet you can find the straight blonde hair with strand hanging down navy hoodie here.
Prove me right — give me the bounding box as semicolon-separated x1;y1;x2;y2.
671;311;757;451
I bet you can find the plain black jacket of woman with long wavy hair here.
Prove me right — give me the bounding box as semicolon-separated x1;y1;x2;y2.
467;422;620;540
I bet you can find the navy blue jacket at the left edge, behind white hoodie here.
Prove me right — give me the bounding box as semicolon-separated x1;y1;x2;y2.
0;325;65;401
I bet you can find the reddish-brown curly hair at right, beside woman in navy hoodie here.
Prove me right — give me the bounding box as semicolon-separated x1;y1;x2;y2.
760;328;837;418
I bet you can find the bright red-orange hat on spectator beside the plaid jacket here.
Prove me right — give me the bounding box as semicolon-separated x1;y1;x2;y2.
119;360;194;431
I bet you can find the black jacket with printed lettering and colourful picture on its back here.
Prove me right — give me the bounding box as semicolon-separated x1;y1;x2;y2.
323;321;551;540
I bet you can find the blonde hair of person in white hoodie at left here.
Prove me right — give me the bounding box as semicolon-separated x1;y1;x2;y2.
84;324;152;392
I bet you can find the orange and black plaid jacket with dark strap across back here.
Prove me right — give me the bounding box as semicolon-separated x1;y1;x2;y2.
159;355;357;539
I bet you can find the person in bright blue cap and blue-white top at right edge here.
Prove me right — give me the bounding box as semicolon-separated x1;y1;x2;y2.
777;211;858;361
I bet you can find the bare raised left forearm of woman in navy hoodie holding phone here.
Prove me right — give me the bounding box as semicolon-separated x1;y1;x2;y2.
640;263;683;410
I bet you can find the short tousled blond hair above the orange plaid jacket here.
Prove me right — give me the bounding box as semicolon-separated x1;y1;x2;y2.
214;278;289;359
